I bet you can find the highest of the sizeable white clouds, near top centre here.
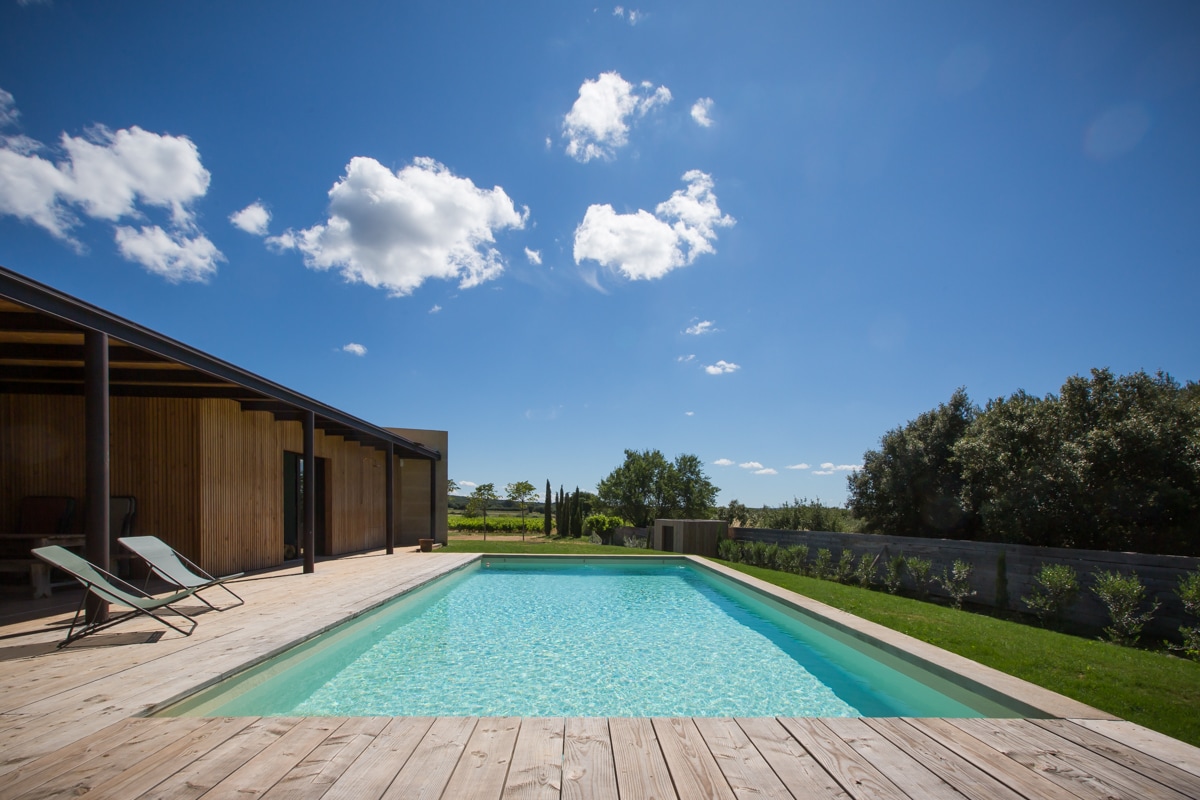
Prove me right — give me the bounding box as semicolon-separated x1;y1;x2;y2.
563;72;671;163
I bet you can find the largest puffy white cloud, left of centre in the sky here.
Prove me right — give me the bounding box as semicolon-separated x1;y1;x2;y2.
268;156;529;296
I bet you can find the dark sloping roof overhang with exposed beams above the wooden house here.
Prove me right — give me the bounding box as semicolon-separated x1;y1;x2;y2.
0;266;442;461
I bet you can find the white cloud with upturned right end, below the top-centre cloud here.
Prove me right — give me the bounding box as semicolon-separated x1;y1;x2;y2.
575;169;734;281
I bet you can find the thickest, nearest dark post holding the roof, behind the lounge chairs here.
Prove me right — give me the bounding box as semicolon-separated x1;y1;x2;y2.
83;331;112;622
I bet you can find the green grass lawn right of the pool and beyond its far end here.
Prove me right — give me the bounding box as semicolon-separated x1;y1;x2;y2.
446;535;1200;746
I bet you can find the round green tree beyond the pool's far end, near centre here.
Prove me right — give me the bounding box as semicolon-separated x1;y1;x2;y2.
596;450;718;528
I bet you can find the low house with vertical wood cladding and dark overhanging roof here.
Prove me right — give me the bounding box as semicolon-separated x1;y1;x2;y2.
0;267;448;585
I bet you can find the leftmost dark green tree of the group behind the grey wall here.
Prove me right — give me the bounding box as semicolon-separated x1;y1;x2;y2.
848;389;979;539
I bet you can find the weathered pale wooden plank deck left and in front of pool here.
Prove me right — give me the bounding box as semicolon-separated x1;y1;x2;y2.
0;553;1200;800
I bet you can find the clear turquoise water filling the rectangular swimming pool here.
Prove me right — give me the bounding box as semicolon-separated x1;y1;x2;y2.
168;557;1037;717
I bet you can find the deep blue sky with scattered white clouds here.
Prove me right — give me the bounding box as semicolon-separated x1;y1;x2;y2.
0;0;1200;505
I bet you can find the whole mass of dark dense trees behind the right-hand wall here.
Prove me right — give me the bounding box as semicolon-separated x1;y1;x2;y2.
847;369;1200;555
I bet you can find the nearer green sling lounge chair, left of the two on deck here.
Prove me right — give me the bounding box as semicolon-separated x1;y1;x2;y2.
32;545;196;648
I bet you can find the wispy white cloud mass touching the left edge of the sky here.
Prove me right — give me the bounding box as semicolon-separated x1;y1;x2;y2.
0;89;223;282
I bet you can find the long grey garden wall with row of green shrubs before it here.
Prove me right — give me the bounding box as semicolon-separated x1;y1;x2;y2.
718;528;1200;651
